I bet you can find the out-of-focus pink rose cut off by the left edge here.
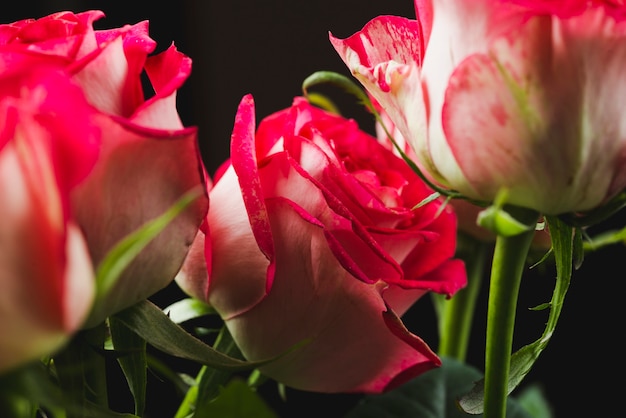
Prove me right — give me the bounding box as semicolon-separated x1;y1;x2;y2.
0;68;100;371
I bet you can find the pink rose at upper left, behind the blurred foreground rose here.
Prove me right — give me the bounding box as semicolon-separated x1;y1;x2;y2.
0;11;208;326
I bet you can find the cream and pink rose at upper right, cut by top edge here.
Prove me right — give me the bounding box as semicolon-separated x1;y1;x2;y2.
331;0;626;214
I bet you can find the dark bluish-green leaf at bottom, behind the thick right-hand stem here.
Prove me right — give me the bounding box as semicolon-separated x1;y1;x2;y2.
344;357;532;418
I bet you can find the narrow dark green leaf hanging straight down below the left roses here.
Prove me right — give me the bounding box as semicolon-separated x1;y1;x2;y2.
109;316;148;416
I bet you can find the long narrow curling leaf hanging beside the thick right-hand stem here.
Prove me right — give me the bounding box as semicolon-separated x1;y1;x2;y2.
459;216;574;414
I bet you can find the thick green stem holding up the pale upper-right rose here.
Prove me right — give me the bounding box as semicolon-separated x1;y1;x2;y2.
484;230;535;418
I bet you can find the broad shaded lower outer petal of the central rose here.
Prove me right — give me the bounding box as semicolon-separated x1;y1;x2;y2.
227;199;439;393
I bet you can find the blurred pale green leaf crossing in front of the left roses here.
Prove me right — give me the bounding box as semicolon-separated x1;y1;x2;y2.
96;189;202;299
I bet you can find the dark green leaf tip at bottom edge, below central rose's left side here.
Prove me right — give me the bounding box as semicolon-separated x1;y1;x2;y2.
194;379;278;418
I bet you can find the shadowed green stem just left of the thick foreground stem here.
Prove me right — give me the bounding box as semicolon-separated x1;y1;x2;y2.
436;239;492;362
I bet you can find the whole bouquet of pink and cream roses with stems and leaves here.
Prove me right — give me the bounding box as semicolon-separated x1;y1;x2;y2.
0;0;626;418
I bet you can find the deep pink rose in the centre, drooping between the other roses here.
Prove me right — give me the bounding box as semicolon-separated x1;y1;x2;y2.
177;96;466;393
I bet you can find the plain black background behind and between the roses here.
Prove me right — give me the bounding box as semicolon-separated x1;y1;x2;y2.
0;0;626;418
